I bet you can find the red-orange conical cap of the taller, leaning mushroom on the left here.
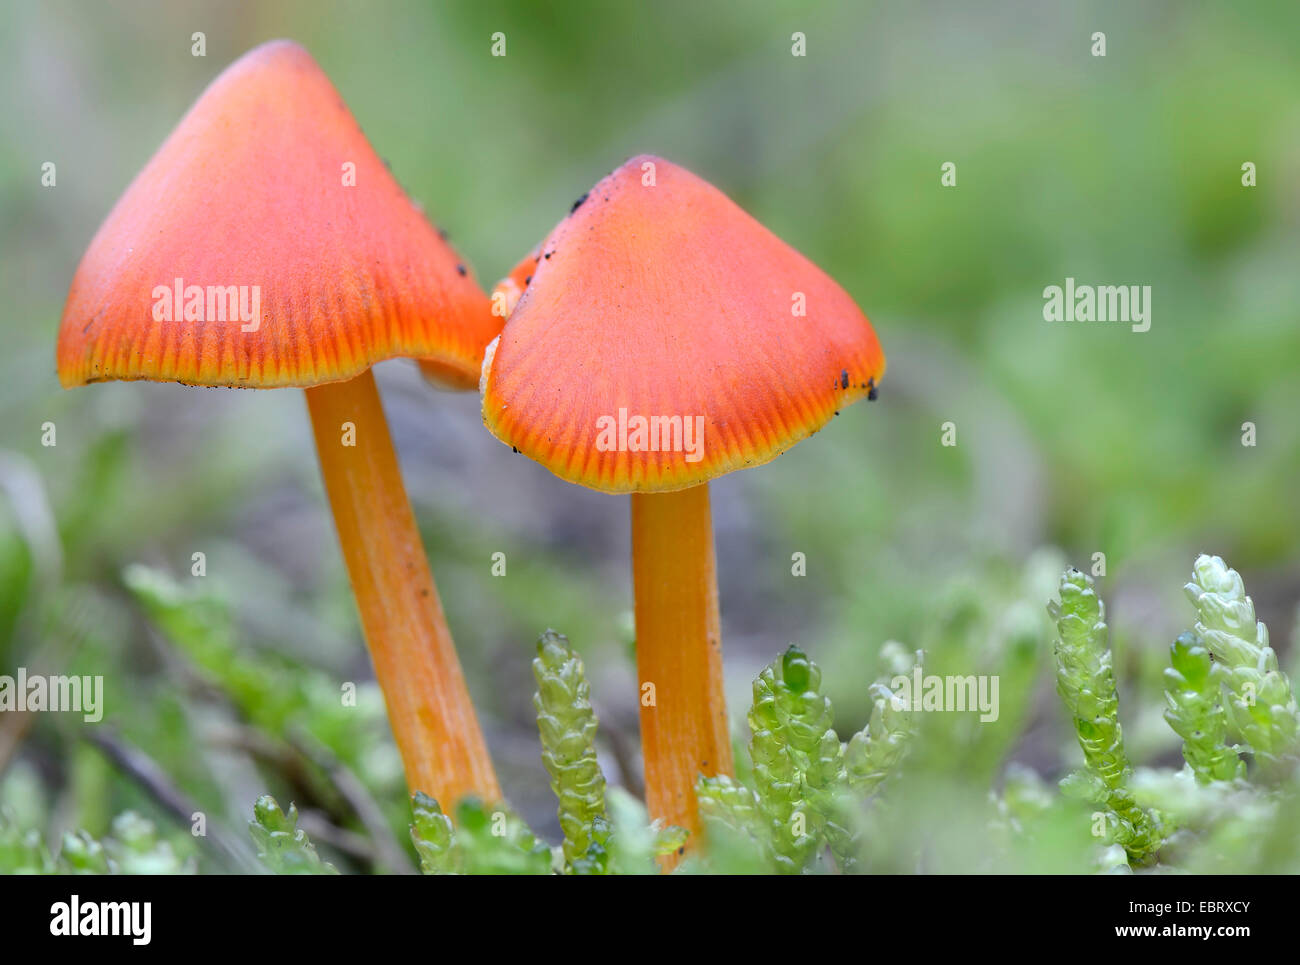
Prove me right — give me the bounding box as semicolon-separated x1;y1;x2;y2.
56;40;501;389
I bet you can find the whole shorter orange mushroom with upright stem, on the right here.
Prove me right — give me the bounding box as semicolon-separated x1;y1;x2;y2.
480;156;885;847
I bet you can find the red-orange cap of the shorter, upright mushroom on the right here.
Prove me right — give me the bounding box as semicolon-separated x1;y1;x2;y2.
480;156;885;493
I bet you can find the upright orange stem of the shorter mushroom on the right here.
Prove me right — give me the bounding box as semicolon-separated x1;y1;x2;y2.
632;484;733;835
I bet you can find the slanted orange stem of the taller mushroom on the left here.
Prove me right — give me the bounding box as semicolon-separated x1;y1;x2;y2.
306;369;502;813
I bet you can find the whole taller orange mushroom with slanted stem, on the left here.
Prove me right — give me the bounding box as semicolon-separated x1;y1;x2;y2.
57;40;501;806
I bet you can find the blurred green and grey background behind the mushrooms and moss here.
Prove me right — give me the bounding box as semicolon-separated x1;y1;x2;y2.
0;0;1300;873
